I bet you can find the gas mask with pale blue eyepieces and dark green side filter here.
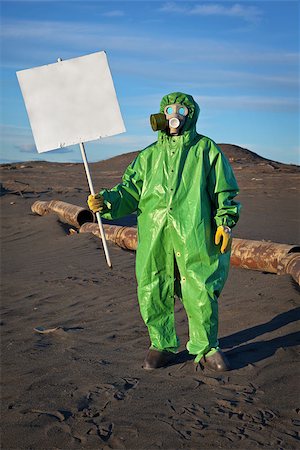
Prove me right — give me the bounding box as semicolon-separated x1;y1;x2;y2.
150;103;189;136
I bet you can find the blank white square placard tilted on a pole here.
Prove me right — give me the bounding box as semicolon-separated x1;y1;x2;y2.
17;51;126;153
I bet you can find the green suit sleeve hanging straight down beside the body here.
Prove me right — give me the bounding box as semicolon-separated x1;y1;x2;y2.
208;145;241;228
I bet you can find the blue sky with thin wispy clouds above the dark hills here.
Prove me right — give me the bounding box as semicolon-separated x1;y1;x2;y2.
0;0;300;164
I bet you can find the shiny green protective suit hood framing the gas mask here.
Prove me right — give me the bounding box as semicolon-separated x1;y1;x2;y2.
158;92;200;141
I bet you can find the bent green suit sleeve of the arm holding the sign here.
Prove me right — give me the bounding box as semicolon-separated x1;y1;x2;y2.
100;156;143;220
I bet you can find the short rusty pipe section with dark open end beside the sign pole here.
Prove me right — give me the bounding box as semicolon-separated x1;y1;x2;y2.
31;200;94;228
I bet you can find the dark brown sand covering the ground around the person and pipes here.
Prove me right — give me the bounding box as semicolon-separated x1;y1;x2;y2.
1;146;300;450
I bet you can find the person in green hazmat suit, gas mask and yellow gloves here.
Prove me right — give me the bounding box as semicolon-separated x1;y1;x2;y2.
88;92;240;371
